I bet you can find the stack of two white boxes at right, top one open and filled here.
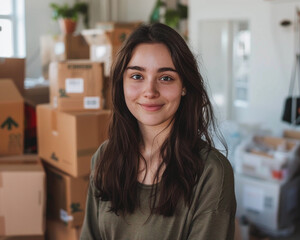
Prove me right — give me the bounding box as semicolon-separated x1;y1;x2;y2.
235;136;300;236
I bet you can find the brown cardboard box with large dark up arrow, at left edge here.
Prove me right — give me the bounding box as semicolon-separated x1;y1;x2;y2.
0;79;24;156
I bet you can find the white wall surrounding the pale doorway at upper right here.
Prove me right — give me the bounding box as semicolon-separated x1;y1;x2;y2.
189;0;300;133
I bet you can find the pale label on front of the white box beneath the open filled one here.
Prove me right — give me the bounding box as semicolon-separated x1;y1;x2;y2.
243;186;265;212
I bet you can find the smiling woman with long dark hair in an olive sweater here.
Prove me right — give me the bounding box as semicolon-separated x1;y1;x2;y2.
81;24;236;240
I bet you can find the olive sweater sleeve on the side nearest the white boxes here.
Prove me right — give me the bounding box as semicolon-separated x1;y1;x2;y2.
188;152;236;240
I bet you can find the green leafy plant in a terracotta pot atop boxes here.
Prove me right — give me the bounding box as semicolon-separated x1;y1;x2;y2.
50;2;89;34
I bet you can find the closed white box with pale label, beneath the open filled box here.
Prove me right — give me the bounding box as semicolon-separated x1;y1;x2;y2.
235;174;300;233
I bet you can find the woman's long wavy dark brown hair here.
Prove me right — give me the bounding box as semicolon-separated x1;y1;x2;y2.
93;23;223;216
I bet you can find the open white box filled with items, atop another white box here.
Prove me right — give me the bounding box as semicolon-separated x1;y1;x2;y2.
235;136;300;181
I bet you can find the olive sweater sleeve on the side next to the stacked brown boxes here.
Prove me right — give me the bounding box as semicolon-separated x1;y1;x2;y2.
80;147;102;240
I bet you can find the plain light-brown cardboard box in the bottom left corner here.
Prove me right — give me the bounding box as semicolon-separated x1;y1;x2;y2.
0;155;45;236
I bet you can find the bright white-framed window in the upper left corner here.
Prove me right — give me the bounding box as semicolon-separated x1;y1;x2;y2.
0;0;25;57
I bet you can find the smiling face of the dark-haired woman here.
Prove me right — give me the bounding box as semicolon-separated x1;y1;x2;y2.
123;43;185;127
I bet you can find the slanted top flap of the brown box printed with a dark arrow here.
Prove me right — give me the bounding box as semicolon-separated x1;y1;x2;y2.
0;79;23;103
